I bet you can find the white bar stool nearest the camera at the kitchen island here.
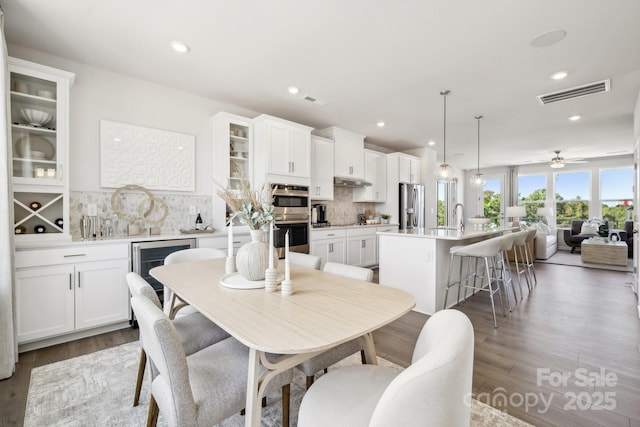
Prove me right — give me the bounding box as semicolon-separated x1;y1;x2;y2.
444;237;506;328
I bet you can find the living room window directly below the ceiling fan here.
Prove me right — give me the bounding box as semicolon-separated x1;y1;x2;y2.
555;172;591;227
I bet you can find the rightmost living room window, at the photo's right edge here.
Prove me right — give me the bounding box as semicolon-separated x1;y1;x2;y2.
600;168;633;229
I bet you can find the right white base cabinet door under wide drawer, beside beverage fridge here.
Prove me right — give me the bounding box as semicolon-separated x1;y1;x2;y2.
75;259;129;329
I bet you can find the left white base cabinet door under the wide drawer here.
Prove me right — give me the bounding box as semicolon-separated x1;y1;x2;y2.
16;265;74;343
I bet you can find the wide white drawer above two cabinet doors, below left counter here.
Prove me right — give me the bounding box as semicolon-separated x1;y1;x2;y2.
16;243;130;268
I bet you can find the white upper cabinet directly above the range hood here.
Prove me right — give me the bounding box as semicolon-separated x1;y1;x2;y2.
316;127;365;179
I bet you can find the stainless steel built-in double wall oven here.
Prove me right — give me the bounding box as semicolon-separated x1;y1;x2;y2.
272;184;310;258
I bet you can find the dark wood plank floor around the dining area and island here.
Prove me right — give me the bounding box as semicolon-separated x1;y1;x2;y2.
0;264;640;427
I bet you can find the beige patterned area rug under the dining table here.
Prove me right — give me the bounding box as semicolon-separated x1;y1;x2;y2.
24;342;530;427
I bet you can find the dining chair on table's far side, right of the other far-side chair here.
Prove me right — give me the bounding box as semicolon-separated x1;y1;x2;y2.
297;262;373;388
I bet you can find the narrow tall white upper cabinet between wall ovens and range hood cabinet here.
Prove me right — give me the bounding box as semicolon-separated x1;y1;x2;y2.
309;135;334;200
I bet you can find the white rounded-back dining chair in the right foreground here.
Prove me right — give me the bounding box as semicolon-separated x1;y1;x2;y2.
298;310;474;427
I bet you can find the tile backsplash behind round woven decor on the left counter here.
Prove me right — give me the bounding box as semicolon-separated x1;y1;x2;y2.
69;191;213;237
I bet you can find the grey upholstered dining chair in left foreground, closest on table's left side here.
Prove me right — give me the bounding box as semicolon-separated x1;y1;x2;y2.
131;296;292;426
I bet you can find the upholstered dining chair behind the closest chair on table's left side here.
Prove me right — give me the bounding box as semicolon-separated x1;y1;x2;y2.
127;272;229;406
